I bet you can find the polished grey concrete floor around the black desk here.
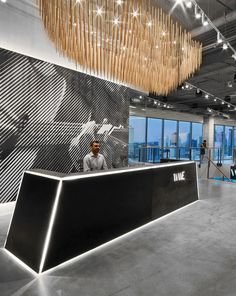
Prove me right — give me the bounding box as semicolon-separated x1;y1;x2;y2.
0;180;236;296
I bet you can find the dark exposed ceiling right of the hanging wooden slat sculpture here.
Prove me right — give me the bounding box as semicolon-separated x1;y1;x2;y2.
136;0;236;120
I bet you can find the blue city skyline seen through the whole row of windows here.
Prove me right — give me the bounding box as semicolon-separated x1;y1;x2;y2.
129;116;236;163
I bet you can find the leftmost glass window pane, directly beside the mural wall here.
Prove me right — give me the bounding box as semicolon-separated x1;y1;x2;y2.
129;116;146;163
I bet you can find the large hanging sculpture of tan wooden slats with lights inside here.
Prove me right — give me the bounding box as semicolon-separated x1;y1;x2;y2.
38;0;202;95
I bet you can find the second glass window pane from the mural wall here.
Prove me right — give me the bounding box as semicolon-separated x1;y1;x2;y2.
147;118;162;162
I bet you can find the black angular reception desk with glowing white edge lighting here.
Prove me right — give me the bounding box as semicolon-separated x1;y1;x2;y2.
5;161;198;273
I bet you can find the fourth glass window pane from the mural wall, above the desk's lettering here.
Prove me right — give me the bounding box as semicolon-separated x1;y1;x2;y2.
178;121;190;159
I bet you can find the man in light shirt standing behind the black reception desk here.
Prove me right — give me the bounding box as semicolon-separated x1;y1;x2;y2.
83;141;108;172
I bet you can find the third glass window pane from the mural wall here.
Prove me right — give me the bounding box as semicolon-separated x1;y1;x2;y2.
163;120;177;158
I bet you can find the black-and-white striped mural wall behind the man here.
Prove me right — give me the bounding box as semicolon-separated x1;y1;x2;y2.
0;49;134;202
